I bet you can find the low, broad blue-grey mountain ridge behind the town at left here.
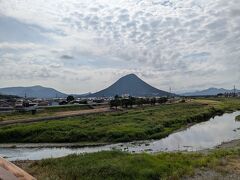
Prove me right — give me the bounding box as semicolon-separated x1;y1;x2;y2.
0;86;67;98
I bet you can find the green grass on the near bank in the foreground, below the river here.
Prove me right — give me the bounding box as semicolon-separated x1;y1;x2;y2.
25;149;240;180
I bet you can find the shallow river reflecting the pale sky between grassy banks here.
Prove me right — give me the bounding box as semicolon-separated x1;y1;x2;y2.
0;111;240;161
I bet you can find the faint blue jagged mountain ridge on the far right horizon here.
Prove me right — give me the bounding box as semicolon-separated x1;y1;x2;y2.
181;87;240;96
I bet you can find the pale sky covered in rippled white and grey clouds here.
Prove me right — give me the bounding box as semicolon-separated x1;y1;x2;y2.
0;0;240;93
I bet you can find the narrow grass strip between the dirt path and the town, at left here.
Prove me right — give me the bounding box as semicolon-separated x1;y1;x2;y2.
0;105;91;121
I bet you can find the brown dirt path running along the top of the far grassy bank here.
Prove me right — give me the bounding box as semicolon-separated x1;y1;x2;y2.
0;107;112;127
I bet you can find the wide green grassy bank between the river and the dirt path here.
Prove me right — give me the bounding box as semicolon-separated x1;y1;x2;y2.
0;99;240;143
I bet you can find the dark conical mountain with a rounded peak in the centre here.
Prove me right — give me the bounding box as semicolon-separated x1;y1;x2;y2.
90;74;170;97
